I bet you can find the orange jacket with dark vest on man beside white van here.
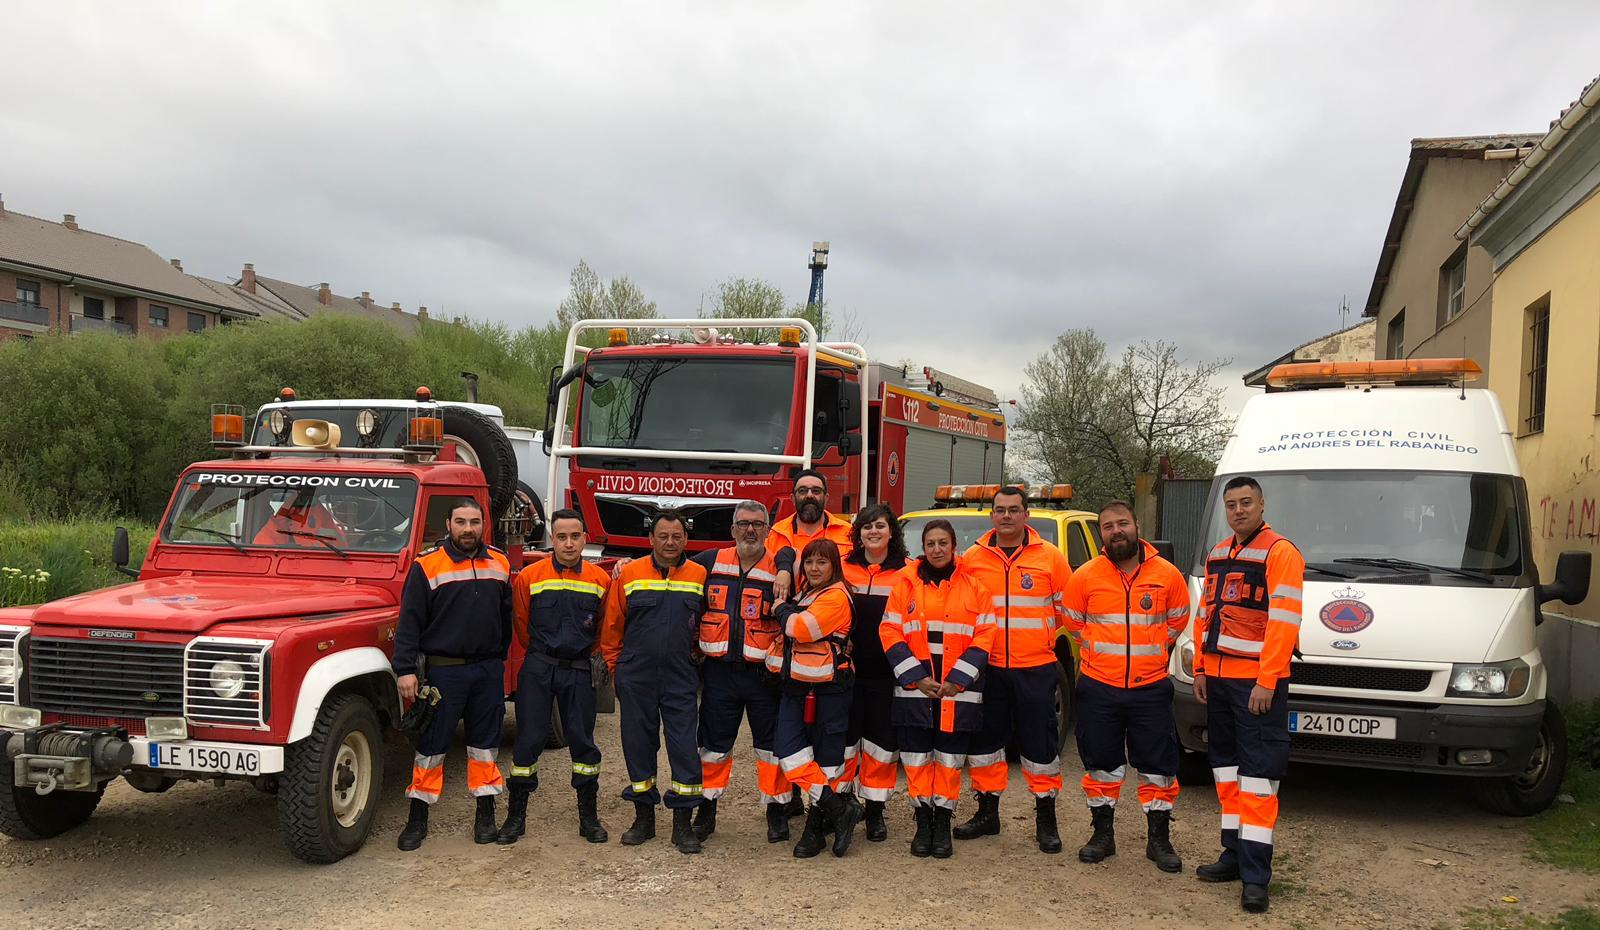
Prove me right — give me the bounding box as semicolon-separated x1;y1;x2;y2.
1195;523;1306;688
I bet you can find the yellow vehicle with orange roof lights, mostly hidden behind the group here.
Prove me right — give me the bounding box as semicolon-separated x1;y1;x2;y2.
901;485;1101;746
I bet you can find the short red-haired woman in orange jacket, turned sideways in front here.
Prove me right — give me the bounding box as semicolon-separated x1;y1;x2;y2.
766;539;861;860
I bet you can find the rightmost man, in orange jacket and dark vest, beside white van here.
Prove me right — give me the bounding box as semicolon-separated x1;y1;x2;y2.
1195;475;1306;912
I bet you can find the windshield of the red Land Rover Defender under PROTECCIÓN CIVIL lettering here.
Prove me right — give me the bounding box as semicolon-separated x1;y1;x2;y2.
162;472;416;552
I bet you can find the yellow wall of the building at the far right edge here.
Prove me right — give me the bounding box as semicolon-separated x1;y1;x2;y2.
1488;195;1600;619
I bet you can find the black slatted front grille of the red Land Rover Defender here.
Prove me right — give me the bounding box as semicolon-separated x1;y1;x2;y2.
27;637;184;719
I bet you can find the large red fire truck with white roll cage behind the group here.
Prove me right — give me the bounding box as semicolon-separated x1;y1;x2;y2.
544;319;1006;557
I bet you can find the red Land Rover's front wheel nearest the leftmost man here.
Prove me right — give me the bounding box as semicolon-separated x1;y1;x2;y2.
278;695;384;863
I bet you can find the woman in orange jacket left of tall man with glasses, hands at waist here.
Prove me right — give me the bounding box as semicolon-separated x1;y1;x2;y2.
878;520;995;860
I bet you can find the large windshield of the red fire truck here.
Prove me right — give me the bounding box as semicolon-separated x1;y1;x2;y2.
579;357;795;455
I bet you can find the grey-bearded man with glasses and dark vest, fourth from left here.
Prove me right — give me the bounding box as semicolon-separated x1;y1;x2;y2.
694;501;795;844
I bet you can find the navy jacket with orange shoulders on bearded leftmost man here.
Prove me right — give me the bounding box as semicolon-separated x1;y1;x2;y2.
392;539;512;675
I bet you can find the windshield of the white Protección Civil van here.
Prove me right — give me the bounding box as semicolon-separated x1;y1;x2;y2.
1195;471;1523;584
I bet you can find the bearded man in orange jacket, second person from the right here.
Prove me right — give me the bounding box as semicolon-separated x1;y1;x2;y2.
1062;501;1189;872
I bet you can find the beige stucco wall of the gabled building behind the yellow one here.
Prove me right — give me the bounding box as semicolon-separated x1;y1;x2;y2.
1376;157;1517;368
